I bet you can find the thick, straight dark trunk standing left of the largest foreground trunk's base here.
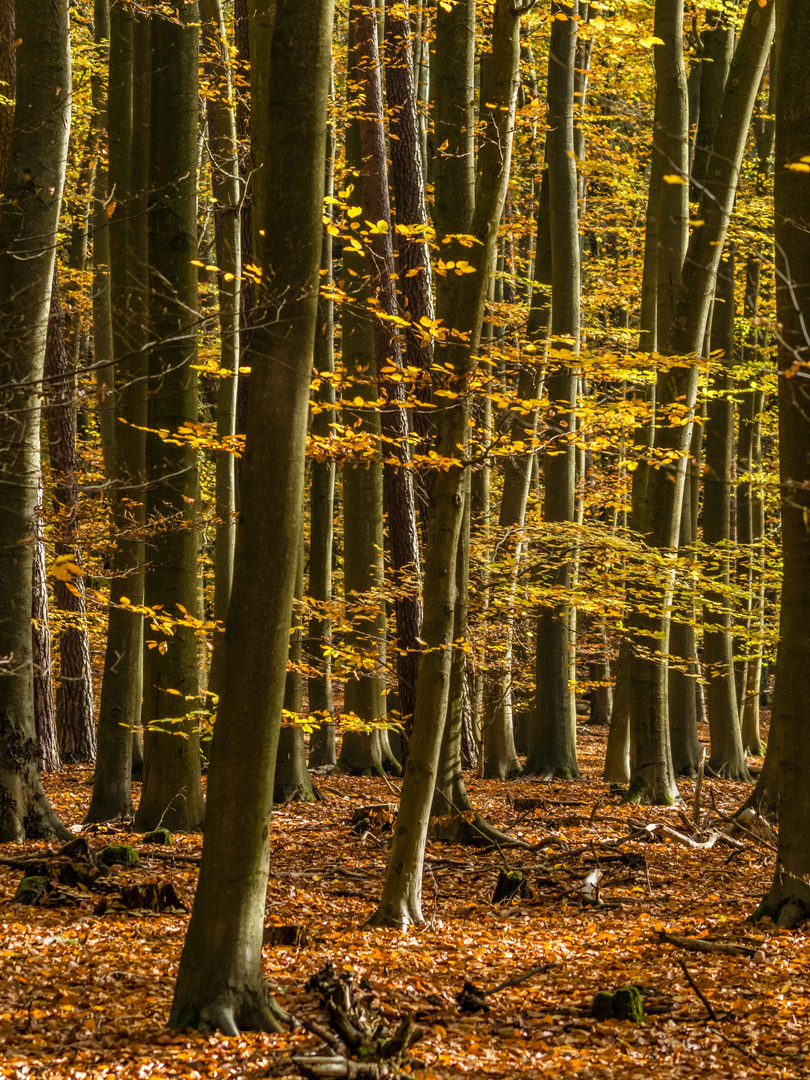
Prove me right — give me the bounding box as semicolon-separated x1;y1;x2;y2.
134;3;203;832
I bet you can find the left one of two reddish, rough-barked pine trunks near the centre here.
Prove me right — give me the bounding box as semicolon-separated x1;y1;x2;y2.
351;0;430;734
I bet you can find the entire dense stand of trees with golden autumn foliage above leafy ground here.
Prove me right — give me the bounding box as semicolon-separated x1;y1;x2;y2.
0;0;810;1034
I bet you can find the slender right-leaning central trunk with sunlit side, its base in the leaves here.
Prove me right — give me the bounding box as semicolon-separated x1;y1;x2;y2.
370;0;521;927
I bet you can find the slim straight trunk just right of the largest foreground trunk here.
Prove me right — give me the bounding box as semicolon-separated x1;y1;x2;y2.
307;83;336;768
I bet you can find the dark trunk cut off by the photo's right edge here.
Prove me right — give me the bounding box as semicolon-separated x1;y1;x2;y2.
757;0;810;927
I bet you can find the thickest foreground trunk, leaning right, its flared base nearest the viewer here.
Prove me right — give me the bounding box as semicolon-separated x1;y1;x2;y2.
170;0;333;1035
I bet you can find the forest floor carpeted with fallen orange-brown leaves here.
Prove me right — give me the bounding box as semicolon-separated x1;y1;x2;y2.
0;728;810;1080
